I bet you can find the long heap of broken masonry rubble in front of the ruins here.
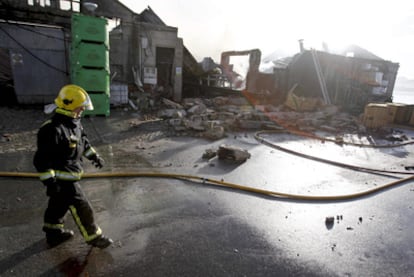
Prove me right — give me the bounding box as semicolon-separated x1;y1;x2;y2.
157;96;365;140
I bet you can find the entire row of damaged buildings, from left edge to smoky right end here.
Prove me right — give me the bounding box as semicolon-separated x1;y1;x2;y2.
0;0;399;115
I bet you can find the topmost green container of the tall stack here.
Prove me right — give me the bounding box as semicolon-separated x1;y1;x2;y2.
72;13;109;48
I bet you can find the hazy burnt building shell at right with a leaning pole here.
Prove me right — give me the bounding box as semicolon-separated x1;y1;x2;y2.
287;46;399;114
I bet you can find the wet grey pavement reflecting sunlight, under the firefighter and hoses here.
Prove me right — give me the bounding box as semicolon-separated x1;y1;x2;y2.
0;105;414;276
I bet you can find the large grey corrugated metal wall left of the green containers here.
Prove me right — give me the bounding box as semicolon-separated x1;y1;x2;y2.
0;22;69;104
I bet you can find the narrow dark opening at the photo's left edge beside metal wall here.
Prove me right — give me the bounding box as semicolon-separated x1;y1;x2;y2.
0;48;17;106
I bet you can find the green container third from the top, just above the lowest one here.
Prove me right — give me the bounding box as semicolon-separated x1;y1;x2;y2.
71;67;110;92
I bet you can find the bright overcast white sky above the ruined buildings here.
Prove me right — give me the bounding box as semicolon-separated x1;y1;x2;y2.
121;0;414;79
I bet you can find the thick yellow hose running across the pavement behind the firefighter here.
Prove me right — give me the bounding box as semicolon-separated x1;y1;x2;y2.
0;171;414;201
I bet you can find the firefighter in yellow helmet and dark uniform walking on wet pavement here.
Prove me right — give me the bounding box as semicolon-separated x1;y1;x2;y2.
33;84;113;248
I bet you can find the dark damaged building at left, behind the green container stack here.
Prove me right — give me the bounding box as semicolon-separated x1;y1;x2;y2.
0;0;199;112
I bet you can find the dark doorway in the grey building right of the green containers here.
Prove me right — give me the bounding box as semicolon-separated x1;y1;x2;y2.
156;47;174;98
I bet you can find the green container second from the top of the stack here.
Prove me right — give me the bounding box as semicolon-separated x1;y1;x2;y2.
71;42;109;71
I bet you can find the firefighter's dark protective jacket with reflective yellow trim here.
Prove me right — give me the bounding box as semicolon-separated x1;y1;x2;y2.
33;109;96;181
